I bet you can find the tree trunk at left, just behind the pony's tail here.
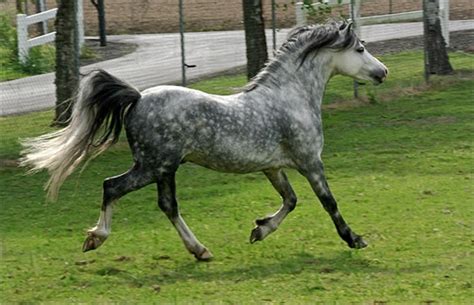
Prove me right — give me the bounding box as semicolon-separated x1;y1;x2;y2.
54;0;79;126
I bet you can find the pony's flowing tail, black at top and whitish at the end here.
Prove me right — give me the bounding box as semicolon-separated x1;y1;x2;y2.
20;70;141;200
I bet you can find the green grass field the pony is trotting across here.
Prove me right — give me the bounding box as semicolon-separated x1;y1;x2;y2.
0;53;474;304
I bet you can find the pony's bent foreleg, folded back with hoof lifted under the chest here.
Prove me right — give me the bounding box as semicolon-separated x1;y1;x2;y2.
250;170;296;243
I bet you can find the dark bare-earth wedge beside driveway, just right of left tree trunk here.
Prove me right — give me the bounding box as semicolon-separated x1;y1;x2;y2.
81;39;138;66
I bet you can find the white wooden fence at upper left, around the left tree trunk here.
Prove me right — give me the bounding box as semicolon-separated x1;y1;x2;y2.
16;1;84;63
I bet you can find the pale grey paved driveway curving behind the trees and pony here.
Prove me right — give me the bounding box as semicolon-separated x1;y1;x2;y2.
0;20;474;116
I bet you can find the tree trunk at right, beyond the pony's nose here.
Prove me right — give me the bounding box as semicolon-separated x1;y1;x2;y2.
423;0;453;80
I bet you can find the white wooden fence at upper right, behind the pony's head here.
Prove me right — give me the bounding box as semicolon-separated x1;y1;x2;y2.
295;0;449;46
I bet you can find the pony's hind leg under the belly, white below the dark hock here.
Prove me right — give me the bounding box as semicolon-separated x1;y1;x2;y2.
157;173;212;261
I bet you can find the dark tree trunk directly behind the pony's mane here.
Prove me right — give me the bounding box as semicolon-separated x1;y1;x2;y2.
242;0;268;79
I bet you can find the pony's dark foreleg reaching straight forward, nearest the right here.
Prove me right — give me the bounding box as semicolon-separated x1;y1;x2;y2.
302;163;367;249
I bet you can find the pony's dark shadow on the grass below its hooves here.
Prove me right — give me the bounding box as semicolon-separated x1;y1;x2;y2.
99;251;434;287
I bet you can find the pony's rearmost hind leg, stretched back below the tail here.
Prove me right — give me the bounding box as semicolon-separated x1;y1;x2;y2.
82;165;153;252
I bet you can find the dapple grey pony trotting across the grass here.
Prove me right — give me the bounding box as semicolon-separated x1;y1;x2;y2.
21;23;388;260
